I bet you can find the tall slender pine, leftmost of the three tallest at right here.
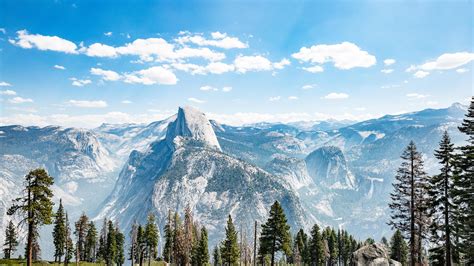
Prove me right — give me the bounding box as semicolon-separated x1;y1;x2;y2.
389;141;427;265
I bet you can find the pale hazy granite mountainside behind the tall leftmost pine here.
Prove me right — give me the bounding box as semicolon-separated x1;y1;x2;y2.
0;125;118;249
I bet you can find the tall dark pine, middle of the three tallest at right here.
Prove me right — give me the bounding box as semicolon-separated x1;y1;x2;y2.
428;131;455;266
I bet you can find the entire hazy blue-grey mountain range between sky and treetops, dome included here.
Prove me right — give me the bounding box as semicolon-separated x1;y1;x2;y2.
0;104;467;256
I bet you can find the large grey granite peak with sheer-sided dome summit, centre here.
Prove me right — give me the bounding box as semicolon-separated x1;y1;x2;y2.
96;107;307;244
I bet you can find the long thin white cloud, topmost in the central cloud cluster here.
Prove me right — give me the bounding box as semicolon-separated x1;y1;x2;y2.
176;32;248;49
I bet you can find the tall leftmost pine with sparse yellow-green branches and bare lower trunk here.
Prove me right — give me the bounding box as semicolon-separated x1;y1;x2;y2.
7;168;54;266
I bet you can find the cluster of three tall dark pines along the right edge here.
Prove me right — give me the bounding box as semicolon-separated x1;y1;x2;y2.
389;98;474;266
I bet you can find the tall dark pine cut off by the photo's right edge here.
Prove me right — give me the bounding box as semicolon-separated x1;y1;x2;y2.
453;97;474;265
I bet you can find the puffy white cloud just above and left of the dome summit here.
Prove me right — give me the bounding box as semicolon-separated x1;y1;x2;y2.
124;66;178;85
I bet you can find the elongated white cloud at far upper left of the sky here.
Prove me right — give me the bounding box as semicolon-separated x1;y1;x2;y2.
9;30;78;54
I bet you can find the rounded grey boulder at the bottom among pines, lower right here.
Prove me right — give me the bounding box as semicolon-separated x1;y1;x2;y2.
351;243;402;266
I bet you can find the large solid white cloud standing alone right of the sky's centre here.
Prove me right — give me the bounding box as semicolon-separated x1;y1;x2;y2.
292;42;377;69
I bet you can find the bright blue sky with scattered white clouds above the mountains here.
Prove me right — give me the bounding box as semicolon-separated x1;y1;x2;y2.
0;0;474;127
